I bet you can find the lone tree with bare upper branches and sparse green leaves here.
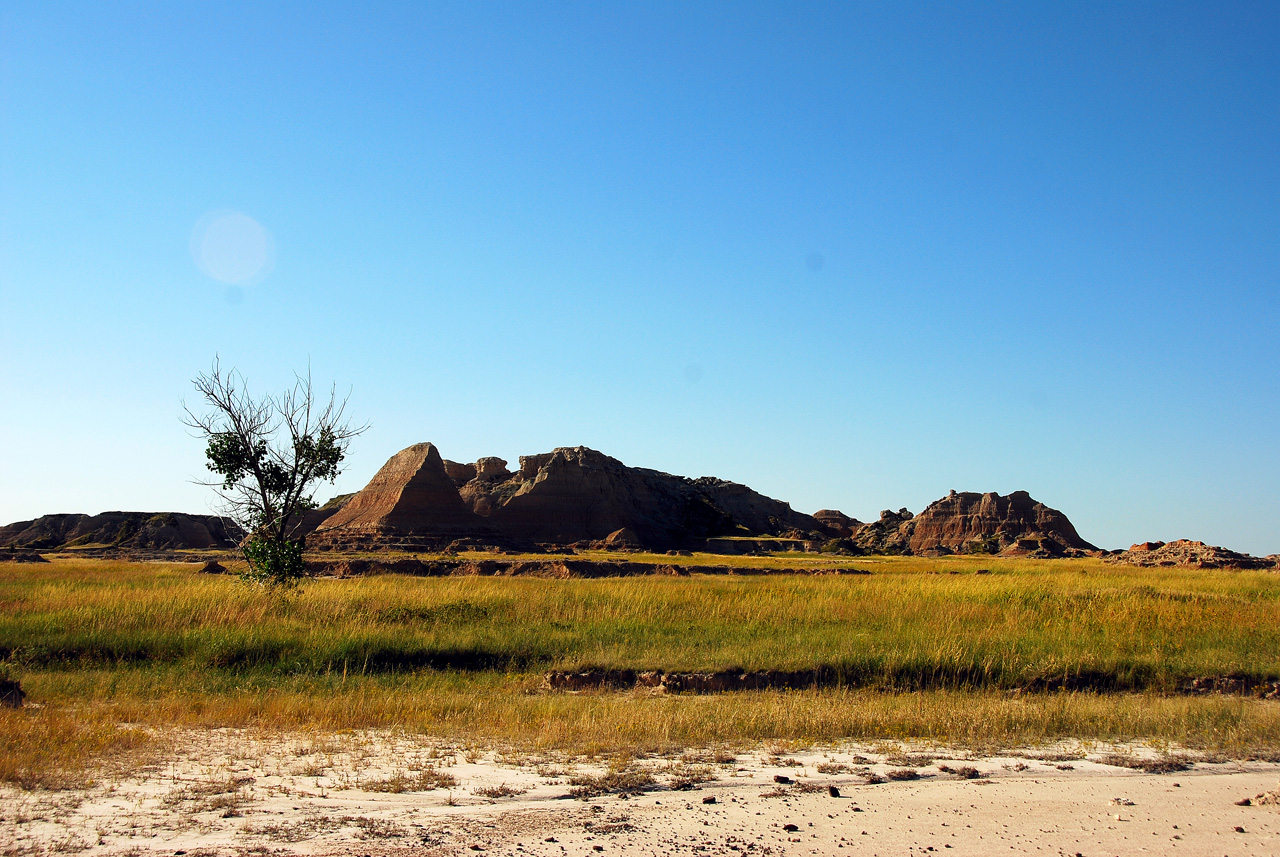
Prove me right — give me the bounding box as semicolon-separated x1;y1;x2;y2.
183;358;369;586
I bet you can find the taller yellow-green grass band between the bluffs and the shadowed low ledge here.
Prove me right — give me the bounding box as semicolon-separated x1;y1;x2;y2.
0;556;1280;691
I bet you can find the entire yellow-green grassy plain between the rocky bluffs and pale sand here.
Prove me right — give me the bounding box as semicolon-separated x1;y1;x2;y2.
0;555;1280;782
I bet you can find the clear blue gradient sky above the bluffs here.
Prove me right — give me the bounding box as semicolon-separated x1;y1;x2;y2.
0;3;1280;554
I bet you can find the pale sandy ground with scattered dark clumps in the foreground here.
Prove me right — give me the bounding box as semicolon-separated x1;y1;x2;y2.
0;730;1280;857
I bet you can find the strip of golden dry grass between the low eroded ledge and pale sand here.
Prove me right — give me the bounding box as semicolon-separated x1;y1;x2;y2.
10;670;1280;753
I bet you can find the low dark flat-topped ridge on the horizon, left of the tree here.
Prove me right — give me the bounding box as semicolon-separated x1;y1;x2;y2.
0;512;242;550
